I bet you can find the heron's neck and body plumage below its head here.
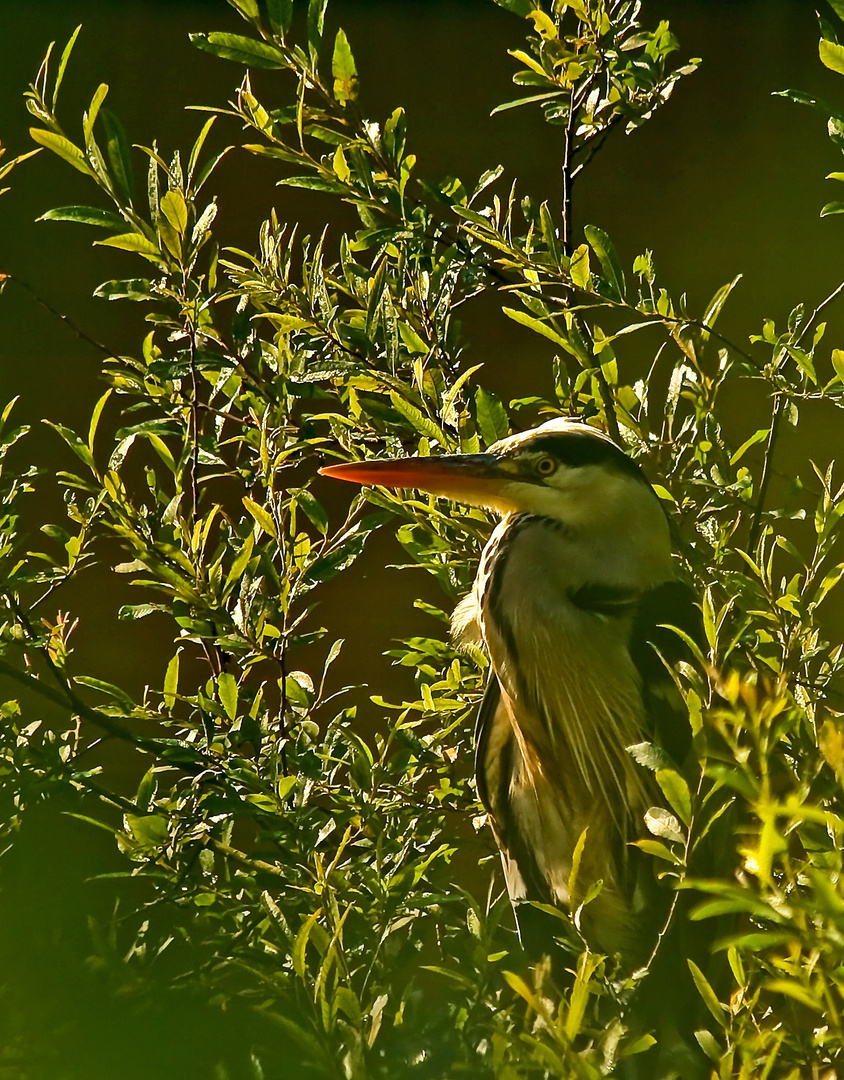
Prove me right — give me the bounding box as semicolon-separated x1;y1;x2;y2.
454;467;673;954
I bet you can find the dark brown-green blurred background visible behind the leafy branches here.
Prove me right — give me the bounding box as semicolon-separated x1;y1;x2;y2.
0;0;844;1077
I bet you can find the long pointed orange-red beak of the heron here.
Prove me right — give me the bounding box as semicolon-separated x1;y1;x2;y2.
320;454;513;509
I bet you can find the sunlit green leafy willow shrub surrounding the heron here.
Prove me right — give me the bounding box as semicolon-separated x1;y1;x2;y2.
0;0;844;1080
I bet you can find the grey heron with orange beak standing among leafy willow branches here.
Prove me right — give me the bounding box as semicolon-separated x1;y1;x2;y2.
320;419;699;967
